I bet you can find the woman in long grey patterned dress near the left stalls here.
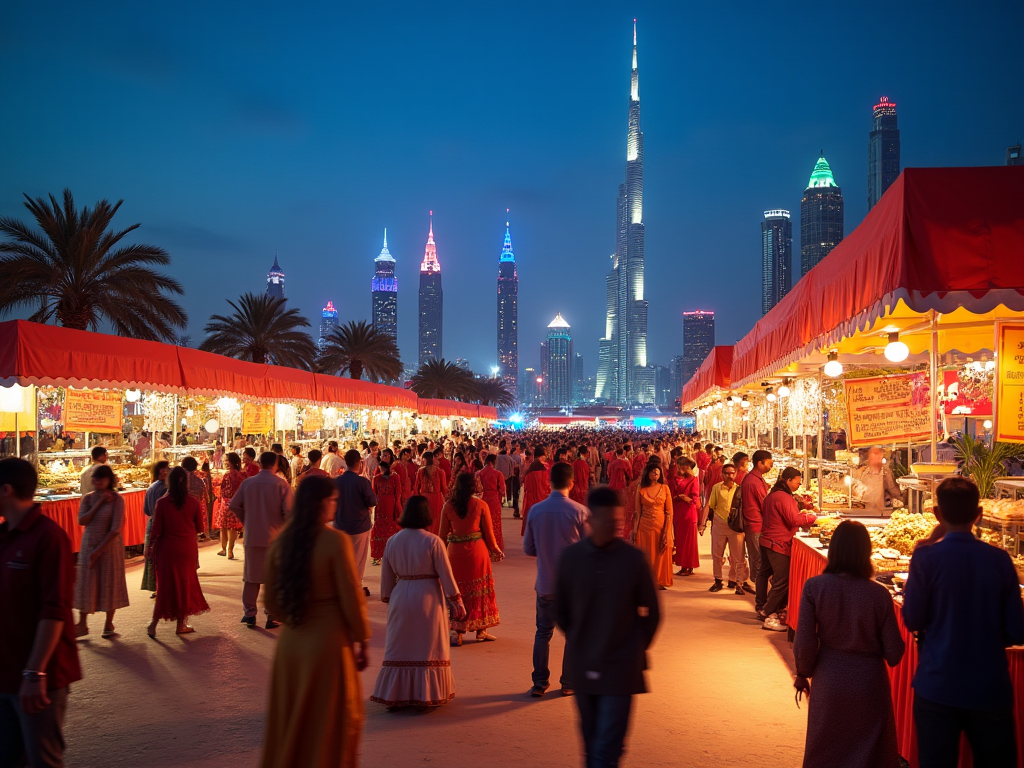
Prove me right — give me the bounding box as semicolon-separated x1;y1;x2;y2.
75;464;128;637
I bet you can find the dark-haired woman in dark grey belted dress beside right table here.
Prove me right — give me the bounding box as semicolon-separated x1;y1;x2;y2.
793;520;906;768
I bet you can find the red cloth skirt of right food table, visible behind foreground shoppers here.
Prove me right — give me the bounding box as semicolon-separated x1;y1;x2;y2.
787;539;1024;768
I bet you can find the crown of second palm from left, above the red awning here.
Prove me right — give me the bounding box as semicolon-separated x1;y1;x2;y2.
199;293;316;370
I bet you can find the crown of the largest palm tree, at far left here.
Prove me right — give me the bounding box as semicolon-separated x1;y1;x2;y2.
0;189;188;341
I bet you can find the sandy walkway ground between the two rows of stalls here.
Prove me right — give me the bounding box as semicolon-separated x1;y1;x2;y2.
67;510;806;768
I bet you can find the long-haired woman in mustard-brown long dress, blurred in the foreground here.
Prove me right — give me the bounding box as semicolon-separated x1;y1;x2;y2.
260;475;370;768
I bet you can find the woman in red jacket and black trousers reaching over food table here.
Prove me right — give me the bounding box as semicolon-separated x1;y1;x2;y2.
757;467;816;632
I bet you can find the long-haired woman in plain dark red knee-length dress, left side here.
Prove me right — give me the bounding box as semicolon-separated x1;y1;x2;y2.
145;467;210;640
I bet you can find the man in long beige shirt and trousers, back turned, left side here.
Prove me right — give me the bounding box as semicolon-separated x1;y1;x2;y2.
231;452;292;630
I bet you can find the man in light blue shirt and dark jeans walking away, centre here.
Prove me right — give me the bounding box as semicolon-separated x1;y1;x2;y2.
522;463;589;698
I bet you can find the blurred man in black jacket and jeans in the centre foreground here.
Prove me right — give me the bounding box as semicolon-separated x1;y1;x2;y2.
555;485;659;766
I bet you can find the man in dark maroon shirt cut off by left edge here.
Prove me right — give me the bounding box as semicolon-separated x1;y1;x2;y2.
0;459;82;766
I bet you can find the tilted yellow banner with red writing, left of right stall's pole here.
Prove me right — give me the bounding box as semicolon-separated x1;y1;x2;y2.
844;373;932;447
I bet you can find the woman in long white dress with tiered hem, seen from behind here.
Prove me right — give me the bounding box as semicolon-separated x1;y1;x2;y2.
370;496;466;710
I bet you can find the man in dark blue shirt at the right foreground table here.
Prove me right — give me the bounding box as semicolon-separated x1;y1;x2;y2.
903;477;1024;768
